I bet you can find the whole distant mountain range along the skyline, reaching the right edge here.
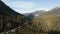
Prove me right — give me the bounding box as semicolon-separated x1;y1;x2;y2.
24;7;60;16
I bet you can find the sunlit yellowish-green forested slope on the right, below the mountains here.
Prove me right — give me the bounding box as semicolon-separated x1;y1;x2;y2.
33;15;60;31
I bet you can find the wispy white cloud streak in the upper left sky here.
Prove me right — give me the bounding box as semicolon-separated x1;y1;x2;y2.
8;1;35;8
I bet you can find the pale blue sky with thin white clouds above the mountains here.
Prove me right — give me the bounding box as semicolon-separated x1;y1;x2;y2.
2;0;60;14
